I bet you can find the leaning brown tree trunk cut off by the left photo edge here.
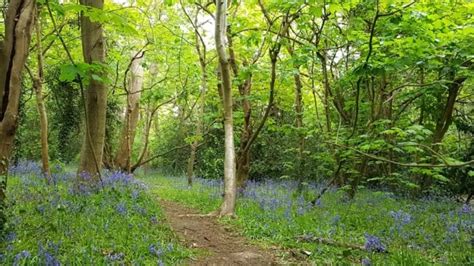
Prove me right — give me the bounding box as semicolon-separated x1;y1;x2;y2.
0;0;36;231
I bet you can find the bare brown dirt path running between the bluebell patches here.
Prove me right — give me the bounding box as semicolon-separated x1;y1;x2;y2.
160;200;279;265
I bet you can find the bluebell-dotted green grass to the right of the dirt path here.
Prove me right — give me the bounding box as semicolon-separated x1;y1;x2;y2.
143;175;474;265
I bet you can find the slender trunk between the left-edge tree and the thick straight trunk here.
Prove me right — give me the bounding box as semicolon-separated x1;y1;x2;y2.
33;12;51;179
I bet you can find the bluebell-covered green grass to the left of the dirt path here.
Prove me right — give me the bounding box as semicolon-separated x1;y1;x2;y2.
0;163;193;265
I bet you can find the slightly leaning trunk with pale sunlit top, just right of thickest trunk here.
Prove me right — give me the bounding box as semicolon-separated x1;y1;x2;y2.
115;53;143;173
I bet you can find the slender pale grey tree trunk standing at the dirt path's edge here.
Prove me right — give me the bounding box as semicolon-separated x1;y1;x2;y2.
215;0;237;216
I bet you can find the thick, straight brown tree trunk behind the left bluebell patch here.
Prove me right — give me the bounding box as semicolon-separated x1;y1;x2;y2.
78;0;107;180
